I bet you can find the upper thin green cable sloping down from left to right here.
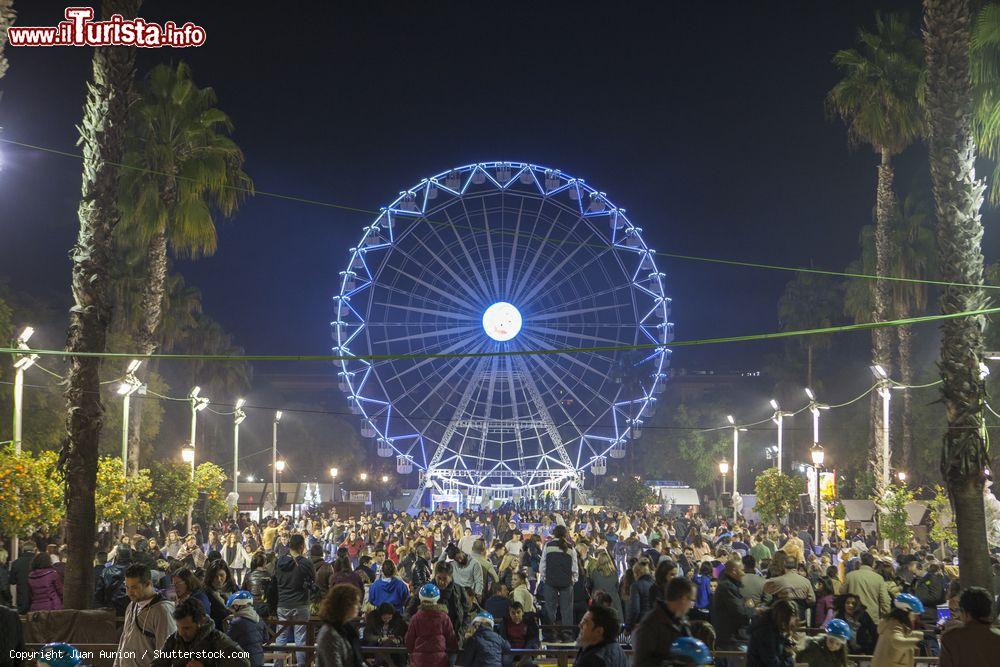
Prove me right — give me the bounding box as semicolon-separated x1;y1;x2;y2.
0;138;1000;289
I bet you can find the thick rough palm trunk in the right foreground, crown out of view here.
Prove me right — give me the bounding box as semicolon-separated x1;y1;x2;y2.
923;0;991;589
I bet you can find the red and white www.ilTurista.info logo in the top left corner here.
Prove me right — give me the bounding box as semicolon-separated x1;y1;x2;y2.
7;7;205;49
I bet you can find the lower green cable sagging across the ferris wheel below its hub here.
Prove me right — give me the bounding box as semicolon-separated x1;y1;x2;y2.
0;308;1000;361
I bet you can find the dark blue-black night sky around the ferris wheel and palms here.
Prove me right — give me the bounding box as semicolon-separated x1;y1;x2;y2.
0;1;994;376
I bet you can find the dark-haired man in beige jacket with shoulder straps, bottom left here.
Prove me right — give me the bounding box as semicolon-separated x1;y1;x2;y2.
114;563;177;667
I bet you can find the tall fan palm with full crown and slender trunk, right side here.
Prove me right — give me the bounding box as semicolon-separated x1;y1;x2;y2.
826;12;924;495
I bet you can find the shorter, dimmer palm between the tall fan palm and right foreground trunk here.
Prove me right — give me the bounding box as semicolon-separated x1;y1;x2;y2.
890;191;937;470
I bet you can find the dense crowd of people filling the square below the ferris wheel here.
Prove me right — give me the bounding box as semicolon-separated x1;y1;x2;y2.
0;508;1000;667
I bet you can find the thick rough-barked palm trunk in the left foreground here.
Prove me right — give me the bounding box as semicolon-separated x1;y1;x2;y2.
60;0;141;609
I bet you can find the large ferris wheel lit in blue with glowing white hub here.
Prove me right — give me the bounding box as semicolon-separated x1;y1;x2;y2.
333;162;673;502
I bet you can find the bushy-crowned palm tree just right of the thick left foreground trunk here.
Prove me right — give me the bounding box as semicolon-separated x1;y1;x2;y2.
121;63;253;478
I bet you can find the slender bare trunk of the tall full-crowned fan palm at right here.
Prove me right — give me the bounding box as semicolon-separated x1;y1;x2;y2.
870;149;896;498
